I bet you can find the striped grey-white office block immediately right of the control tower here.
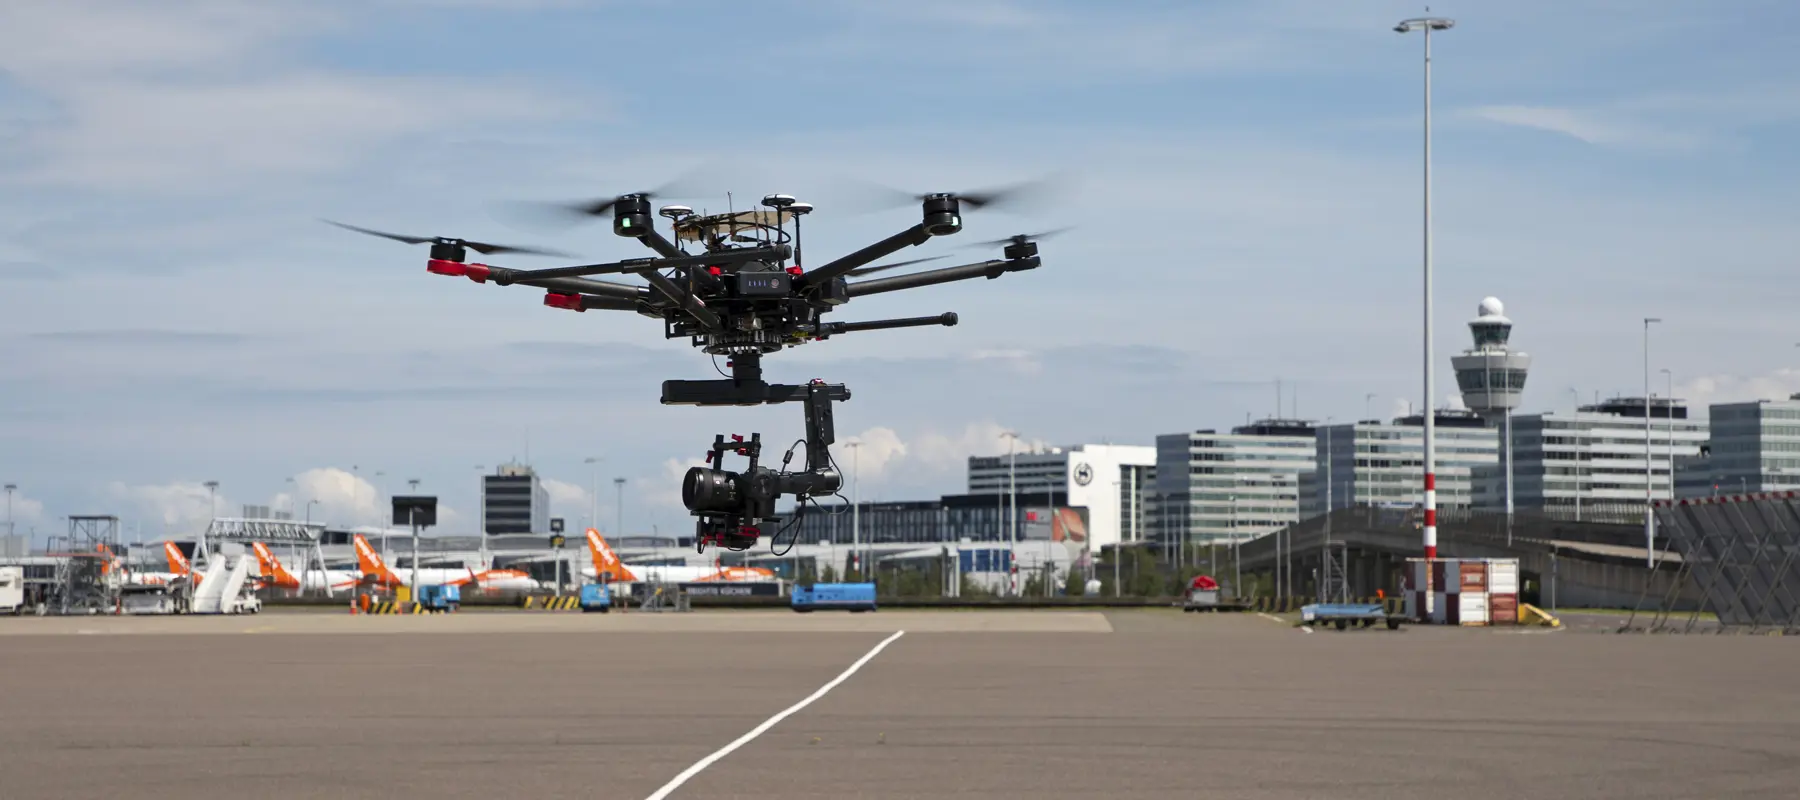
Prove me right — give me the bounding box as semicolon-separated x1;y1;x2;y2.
1478;396;1706;523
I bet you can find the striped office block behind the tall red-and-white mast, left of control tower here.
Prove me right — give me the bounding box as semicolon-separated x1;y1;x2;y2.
1301;409;1499;519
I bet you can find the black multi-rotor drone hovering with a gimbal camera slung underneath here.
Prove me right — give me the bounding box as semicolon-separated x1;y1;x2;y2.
326;189;1066;551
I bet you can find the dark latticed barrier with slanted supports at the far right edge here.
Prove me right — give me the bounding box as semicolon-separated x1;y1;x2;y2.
1624;492;1800;634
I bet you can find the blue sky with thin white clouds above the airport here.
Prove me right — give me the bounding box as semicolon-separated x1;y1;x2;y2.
0;0;1800;541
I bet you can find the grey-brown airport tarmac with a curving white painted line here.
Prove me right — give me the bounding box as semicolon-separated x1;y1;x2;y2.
0;611;1800;800
